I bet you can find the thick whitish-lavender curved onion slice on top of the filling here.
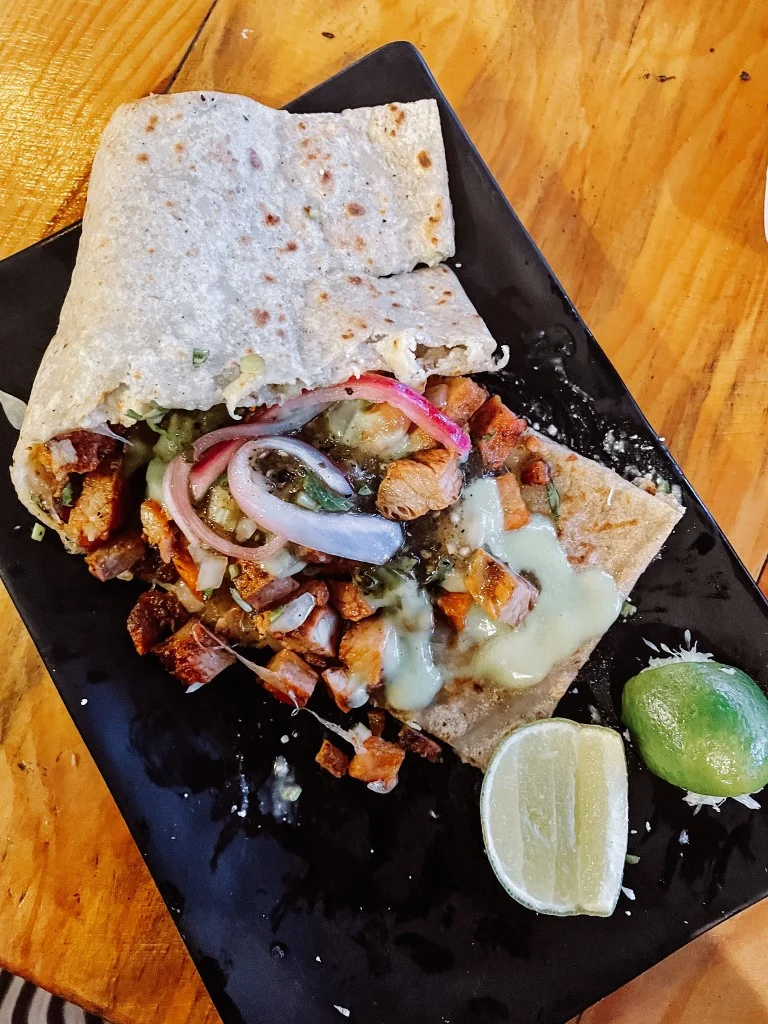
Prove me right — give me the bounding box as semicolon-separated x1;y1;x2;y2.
228;438;403;565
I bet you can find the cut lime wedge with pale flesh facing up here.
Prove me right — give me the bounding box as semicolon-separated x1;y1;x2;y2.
480;718;628;918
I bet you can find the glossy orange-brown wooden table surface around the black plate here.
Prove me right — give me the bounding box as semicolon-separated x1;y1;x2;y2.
0;0;768;1024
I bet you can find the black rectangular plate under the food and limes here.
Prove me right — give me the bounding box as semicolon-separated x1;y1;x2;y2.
0;43;768;1024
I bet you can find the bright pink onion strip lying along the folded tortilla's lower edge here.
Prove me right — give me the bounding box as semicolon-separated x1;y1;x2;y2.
249;374;472;458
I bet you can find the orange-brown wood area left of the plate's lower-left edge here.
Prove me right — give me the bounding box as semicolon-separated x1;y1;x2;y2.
0;589;219;1024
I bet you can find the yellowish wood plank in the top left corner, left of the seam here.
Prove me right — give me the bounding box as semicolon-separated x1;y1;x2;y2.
0;0;211;258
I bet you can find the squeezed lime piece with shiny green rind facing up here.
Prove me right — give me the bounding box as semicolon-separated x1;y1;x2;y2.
622;662;768;797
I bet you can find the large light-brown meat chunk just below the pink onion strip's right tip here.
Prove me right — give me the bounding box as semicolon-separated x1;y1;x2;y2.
376;447;462;520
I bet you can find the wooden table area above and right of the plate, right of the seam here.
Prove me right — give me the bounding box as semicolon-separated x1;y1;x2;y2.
176;0;768;574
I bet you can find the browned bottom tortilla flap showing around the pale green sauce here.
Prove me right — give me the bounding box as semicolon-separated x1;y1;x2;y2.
389;435;683;769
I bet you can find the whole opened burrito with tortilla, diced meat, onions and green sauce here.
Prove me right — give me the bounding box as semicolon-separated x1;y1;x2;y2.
11;93;682;793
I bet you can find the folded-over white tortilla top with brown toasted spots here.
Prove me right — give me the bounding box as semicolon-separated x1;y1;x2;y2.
12;92;505;527
